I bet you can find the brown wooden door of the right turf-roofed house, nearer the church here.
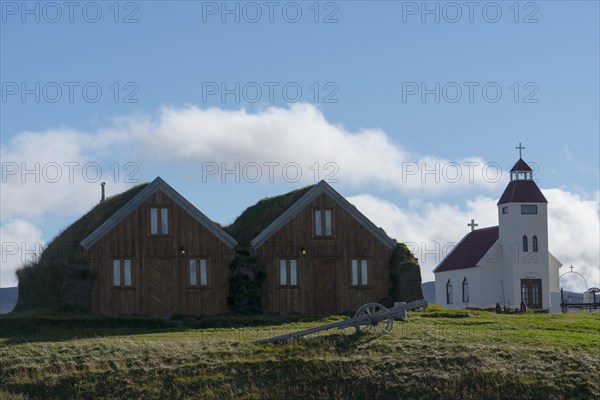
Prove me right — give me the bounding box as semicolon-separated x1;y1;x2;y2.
313;258;337;314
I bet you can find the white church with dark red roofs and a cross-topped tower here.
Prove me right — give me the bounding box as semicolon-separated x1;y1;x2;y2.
433;144;562;312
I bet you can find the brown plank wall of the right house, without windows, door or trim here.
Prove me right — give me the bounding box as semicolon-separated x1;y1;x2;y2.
256;194;391;314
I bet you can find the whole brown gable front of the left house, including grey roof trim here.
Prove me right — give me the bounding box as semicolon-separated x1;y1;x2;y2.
81;178;236;316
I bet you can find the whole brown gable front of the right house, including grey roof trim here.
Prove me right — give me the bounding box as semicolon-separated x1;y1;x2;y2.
239;181;396;314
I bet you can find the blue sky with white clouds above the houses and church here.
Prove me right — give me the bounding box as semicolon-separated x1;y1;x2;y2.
0;1;600;290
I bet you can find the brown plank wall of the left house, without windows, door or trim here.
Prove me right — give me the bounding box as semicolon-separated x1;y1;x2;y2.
89;192;234;315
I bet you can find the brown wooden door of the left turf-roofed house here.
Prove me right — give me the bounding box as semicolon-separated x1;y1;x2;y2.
145;258;173;315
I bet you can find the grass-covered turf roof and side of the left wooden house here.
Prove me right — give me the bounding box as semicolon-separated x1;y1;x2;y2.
15;184;147;310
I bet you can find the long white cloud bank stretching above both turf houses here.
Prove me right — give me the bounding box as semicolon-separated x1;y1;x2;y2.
0;104;506;222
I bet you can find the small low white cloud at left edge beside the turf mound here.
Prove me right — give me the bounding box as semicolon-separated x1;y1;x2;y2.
0;219;44;287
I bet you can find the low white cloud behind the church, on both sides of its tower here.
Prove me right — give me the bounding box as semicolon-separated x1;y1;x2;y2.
348;189;600;290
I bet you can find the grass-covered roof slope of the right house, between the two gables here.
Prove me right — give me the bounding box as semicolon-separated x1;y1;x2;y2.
225;185;314;245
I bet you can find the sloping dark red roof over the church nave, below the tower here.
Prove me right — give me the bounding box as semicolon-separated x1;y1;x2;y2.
433;226;500;272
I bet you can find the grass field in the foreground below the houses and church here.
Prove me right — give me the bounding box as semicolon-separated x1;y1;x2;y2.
0;306;600;399
